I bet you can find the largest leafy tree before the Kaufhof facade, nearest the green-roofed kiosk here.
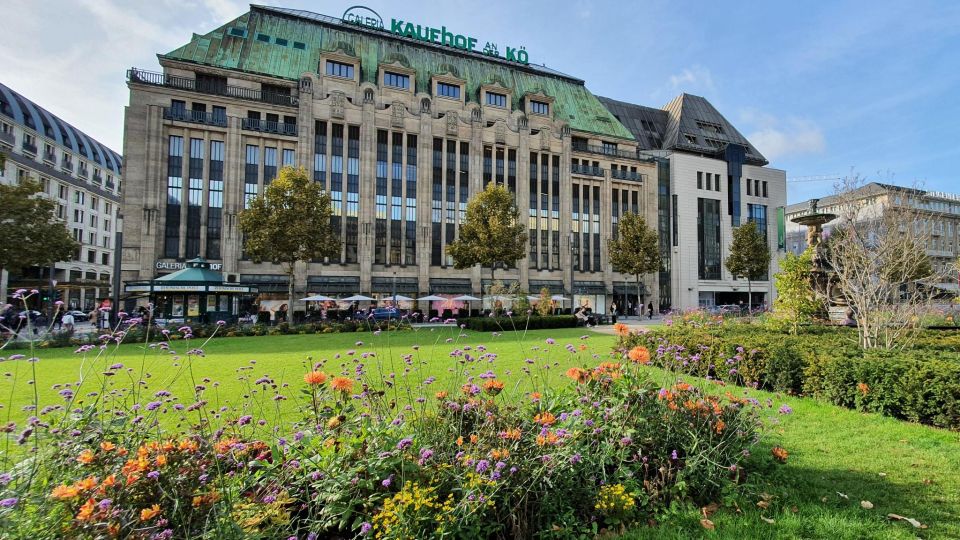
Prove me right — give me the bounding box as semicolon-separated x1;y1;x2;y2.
240;167;340;319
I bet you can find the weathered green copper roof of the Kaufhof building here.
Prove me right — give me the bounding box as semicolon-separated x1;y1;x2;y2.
161;6;634;140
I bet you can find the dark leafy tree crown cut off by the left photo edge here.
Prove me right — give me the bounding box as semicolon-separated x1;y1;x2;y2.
0;180;80;300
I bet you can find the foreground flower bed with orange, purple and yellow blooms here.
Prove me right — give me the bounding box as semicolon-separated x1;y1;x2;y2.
0;330;768;538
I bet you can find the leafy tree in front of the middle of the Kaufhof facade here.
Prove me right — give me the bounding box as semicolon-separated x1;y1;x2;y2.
447;182;527;305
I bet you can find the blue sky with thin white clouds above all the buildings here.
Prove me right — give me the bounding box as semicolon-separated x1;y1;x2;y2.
0;0;960;202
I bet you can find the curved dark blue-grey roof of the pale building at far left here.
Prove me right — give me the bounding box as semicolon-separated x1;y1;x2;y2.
0;83;123;174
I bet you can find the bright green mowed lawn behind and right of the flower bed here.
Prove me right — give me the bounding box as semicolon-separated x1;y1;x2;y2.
0;328;960;539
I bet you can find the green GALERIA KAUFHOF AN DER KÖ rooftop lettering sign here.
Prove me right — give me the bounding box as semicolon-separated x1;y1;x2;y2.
341;6;530;65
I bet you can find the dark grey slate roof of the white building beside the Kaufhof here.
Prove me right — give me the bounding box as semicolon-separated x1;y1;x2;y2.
599;94;769;166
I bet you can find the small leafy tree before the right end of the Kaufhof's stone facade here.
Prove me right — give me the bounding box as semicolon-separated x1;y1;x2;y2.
609;212;660;312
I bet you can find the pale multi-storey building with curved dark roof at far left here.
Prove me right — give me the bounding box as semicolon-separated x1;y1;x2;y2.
0;84;122;310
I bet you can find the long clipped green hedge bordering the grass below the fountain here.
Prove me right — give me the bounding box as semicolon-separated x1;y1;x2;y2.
621;325;960;430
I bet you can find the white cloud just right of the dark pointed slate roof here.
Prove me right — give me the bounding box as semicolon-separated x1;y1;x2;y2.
741;110;827;161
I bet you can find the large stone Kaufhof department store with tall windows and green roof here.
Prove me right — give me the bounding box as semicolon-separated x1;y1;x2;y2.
122;6;788;312
